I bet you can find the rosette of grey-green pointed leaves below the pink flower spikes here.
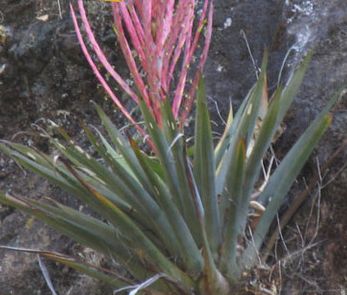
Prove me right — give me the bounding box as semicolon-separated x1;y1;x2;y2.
0;51;334;295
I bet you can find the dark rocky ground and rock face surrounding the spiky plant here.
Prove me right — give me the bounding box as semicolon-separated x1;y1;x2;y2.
0;0;347;295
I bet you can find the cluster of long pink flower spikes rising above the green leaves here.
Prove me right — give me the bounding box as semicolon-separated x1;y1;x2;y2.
71;0;213;134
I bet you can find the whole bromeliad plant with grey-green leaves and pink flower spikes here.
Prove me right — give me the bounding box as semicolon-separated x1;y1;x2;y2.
0;0;336;295
